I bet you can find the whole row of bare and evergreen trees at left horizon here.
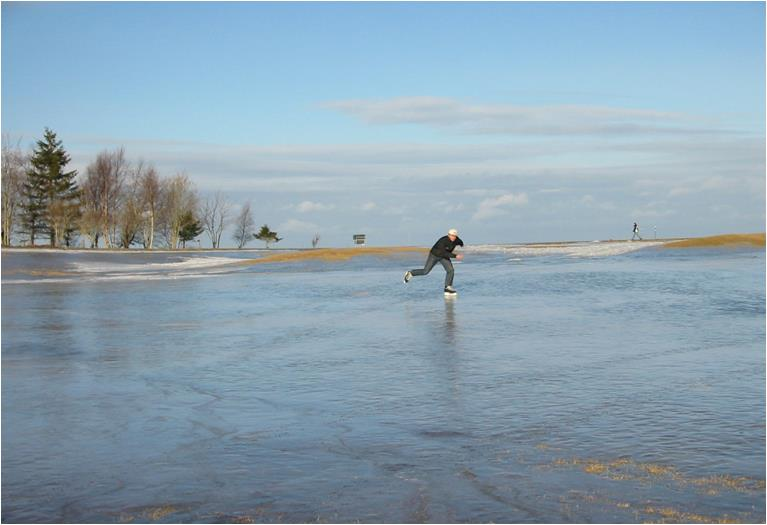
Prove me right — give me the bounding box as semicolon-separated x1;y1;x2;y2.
0;128;288;250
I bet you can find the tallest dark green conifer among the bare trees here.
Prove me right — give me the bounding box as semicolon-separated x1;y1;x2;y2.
22;128;79;247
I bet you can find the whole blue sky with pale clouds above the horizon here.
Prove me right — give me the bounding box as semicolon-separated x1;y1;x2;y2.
1;1;765;247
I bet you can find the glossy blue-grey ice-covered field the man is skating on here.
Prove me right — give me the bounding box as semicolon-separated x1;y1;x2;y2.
2;242;765;523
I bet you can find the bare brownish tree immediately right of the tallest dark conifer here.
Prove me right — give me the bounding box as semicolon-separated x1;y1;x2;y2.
82;148;128;248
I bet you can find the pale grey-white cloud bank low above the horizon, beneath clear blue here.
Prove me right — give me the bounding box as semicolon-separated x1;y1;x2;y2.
21;94;765;245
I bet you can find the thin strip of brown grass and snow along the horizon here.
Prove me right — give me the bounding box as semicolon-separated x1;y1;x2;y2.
2;233;765;254
